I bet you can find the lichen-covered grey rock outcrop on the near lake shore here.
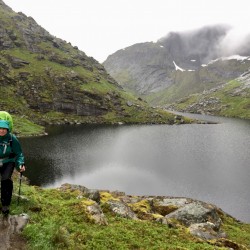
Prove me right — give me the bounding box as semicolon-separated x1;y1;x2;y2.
59;184;240;245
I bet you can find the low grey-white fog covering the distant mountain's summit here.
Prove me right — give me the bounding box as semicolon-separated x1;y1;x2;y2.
158;24;250;63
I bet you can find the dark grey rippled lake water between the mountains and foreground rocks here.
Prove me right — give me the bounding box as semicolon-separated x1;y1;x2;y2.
20;114;250;223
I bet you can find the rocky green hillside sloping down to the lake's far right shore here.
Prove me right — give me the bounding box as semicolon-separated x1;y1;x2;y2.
167;80;250;119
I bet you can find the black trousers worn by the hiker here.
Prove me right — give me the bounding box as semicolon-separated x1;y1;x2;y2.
0;162;15;206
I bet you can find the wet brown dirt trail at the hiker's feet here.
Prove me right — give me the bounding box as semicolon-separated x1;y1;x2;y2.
0;214;28;250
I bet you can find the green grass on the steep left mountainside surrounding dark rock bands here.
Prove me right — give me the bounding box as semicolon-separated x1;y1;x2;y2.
0;49;188;135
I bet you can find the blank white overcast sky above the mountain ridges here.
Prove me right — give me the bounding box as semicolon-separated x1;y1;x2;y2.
3;0;250;62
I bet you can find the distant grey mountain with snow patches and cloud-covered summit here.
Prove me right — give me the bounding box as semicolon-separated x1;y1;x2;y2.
103;25;250;118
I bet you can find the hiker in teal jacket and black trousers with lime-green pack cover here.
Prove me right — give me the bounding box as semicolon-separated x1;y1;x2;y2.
0;111;25;215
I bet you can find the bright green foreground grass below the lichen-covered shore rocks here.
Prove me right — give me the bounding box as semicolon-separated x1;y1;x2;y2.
11;174;250;250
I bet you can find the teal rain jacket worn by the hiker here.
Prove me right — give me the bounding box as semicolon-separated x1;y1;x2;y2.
0;132;24;171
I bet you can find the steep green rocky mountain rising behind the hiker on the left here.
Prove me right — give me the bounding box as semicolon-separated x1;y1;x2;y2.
0;0;184;135
